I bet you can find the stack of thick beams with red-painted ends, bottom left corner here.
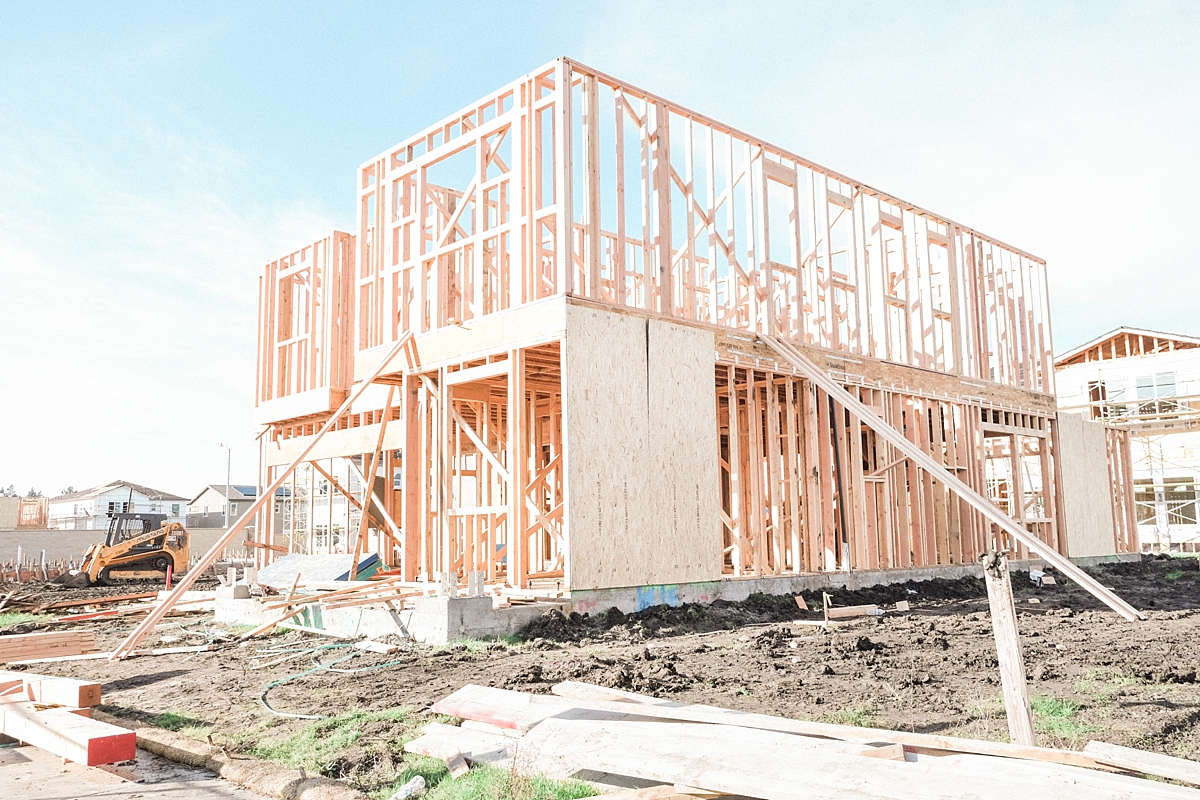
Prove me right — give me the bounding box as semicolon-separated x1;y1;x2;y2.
0;666;137;766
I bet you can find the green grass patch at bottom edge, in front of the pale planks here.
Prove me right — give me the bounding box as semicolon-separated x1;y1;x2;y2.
371;758;600;800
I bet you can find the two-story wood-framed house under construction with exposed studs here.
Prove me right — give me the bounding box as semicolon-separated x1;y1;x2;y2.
250;59;1138;606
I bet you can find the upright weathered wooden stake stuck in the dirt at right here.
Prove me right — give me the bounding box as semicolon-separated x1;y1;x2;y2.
983;551;1036;745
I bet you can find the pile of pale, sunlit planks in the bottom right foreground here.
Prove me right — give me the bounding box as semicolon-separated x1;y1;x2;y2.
406;681;1200;800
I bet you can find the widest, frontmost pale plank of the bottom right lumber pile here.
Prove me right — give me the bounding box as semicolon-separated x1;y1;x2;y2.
520;718;1200;800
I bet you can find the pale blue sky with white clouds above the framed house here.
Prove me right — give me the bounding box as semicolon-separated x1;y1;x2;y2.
0;0;1200;495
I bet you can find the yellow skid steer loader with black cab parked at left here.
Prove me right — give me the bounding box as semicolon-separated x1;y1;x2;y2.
58;513;191;588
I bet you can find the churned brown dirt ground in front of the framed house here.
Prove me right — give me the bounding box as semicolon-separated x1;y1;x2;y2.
7;558;1200;796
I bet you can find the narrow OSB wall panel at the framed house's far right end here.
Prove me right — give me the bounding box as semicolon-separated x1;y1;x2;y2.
1058;414;1116;558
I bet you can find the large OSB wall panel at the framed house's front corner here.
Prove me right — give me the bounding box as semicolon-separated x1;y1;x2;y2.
563;306;720;589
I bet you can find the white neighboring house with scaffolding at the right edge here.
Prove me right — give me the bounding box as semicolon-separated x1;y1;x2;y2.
1055;327;1200;553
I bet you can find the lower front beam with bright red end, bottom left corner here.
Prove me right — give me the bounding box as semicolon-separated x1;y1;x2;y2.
0;704;137;766
